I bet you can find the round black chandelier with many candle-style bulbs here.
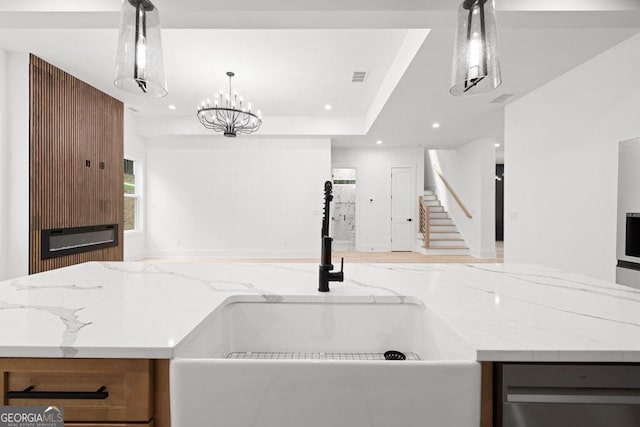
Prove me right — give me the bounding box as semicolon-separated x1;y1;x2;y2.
198;71;262;138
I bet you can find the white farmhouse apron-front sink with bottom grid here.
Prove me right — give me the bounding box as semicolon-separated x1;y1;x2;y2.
171;301;480;427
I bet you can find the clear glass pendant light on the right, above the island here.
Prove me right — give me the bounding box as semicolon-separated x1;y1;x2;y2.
450;0;502;96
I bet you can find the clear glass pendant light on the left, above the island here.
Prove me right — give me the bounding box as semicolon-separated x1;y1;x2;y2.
114;0;167;97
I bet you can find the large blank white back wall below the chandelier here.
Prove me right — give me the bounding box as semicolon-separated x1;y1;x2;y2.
146;137;331;257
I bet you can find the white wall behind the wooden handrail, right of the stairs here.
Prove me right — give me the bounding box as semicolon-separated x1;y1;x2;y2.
425;139;496;258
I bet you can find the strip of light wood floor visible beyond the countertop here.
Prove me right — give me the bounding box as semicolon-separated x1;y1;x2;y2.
140;247;502;264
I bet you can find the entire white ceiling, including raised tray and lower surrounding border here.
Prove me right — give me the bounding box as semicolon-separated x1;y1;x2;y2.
0;0;640;148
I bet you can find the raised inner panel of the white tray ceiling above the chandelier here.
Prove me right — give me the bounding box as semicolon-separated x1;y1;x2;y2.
0;29;407;117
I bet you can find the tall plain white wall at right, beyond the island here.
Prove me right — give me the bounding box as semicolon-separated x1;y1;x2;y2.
505;35;640;281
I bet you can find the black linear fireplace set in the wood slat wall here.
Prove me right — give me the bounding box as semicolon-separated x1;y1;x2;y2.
41;224;118;259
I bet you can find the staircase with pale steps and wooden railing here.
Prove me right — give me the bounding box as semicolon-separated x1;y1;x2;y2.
419;191;469;255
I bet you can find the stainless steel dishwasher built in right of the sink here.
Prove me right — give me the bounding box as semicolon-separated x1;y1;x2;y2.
495;363;640;427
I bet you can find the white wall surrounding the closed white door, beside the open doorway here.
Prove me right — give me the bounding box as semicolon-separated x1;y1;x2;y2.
331;147;424;251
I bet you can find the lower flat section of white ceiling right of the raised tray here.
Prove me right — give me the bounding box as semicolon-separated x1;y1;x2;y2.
334;29;638;148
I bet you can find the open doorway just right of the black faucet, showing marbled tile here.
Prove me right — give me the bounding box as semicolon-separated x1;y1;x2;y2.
331;168;356;251
